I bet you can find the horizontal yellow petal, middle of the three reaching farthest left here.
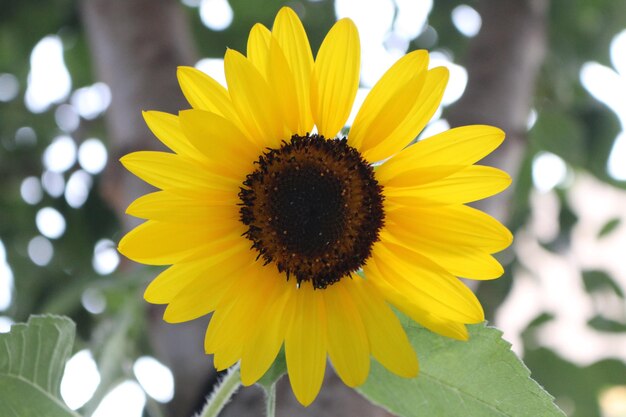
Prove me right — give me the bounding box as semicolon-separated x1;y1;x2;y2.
126;191;239;224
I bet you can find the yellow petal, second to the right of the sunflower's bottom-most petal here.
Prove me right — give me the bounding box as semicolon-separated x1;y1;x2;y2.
350;280;419;378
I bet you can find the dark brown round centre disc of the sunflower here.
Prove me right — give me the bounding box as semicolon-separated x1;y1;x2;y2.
239;135;384;288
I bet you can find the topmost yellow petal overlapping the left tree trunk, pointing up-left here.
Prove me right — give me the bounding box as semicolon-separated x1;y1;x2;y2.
177;67;238;122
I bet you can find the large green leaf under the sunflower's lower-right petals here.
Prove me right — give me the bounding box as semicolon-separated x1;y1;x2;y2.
358;323;564;417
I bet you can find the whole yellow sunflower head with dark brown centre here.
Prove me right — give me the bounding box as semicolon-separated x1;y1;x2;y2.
119;8;512;405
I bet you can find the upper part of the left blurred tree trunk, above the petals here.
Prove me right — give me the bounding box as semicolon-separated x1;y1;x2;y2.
81;0;196;218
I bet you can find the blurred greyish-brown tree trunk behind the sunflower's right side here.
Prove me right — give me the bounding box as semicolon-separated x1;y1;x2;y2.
447;0;548;221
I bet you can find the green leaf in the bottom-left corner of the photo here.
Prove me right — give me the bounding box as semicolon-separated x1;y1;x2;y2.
0;316;78;417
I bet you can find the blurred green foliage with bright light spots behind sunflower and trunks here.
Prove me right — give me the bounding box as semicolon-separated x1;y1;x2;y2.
0;0;626;417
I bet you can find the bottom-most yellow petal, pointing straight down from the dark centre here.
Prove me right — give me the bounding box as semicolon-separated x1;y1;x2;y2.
285;282;327;406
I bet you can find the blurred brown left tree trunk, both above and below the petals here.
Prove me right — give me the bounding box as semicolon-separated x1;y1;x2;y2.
81;0;215;417
